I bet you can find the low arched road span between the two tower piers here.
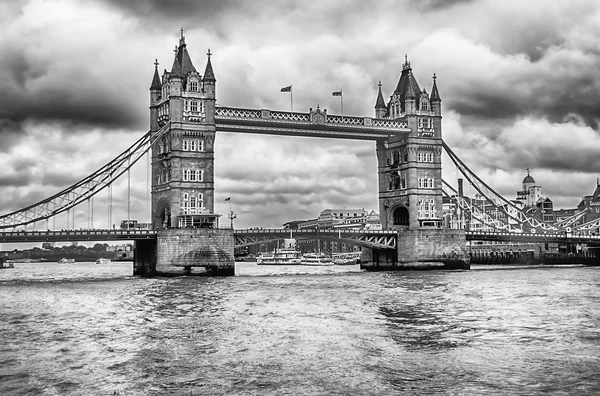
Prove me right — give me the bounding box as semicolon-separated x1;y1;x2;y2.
233;228;398;249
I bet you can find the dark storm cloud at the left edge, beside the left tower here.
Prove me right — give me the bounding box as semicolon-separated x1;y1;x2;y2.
0;51;145;133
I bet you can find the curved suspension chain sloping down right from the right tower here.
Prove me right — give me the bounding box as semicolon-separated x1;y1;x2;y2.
442;141;562;232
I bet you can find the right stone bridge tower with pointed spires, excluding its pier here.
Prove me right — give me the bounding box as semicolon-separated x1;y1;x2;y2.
375;59;442;230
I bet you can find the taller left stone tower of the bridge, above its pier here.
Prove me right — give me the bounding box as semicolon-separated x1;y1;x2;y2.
150;29;218;229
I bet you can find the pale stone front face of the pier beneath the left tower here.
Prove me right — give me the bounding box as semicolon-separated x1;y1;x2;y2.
156;228;235;276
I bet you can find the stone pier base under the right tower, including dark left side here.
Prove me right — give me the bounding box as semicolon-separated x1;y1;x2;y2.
361;228;470;271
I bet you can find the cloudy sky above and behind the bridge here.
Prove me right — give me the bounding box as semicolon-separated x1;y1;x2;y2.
0;0;600;232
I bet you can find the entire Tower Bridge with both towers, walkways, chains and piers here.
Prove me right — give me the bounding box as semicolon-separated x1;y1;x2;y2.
0;32;600;275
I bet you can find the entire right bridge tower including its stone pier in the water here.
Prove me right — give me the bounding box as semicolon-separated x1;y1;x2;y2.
364;58;468;269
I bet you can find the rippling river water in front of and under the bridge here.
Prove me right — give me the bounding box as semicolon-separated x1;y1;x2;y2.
0;263;600;395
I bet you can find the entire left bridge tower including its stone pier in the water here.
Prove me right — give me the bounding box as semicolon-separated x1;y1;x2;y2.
142;29;235;275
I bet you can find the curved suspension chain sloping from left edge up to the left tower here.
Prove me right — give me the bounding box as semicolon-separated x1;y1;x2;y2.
0;123;169;229
